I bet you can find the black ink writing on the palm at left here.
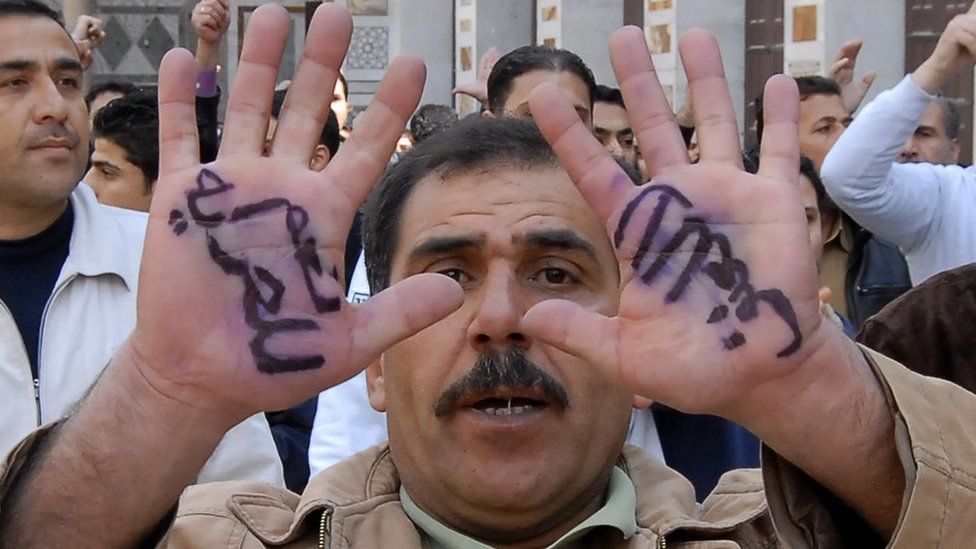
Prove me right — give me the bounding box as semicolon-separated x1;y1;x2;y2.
169;169;342;374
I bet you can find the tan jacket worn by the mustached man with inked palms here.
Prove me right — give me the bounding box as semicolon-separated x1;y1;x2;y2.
0;346;976;549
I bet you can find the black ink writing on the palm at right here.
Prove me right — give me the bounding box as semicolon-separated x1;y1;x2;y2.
613;185;803;357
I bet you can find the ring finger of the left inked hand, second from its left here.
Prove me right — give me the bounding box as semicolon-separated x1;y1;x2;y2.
219;4;291;156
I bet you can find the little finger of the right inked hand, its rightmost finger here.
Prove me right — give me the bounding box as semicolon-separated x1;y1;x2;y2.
759;74;800;184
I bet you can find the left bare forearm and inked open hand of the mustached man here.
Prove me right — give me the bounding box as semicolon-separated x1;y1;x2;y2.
0;4;461;547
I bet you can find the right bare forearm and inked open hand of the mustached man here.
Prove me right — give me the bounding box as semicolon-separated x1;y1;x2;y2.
524;28;905;536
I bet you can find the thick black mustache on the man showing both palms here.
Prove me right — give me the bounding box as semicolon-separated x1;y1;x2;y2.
434;347;569;417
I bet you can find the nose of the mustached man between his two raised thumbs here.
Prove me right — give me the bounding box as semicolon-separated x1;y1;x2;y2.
468;268;531;352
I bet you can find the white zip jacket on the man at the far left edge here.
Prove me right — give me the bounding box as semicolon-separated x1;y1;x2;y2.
0;183;284;486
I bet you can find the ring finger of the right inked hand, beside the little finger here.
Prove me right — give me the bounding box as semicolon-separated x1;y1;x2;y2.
678;29;744;168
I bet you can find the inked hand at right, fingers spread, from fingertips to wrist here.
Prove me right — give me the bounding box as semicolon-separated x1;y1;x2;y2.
525;27;833;417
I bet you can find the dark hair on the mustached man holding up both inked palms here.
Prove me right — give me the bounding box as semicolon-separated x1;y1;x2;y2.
363;116;560;292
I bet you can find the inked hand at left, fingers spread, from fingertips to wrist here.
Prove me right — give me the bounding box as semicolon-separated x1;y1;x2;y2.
129;4;461;418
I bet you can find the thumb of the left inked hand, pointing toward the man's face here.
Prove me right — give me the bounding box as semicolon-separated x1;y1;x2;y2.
351;273;464;364
